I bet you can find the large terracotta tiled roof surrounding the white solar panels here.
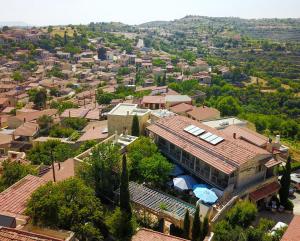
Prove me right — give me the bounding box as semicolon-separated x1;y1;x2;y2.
147;116;271;174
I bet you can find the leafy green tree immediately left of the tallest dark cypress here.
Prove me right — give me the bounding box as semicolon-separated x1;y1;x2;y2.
78;143;121;199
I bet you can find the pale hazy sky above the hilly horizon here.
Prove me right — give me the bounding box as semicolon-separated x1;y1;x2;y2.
0;0;300;25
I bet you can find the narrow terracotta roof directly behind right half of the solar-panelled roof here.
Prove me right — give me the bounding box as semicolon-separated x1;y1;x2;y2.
222;125;268;147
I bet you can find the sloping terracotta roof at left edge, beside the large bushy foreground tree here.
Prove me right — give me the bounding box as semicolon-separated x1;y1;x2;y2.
0;175;46;215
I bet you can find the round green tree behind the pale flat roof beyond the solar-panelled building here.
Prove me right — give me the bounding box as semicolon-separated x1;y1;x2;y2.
217;96;241;116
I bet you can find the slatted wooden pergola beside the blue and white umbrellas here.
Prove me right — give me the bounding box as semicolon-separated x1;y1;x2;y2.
116;182;196;227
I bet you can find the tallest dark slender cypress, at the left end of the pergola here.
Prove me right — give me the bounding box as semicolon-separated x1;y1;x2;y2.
120;154;132;219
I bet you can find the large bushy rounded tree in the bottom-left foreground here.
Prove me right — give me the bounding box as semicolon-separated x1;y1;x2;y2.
26;178;103;240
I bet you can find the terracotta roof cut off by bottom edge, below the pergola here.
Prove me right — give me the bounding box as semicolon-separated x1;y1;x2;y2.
132;228;187;241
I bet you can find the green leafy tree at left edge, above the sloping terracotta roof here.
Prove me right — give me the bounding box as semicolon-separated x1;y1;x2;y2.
0;160;37;191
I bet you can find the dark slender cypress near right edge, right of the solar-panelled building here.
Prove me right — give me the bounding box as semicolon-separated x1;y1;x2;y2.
279;156;291;206
